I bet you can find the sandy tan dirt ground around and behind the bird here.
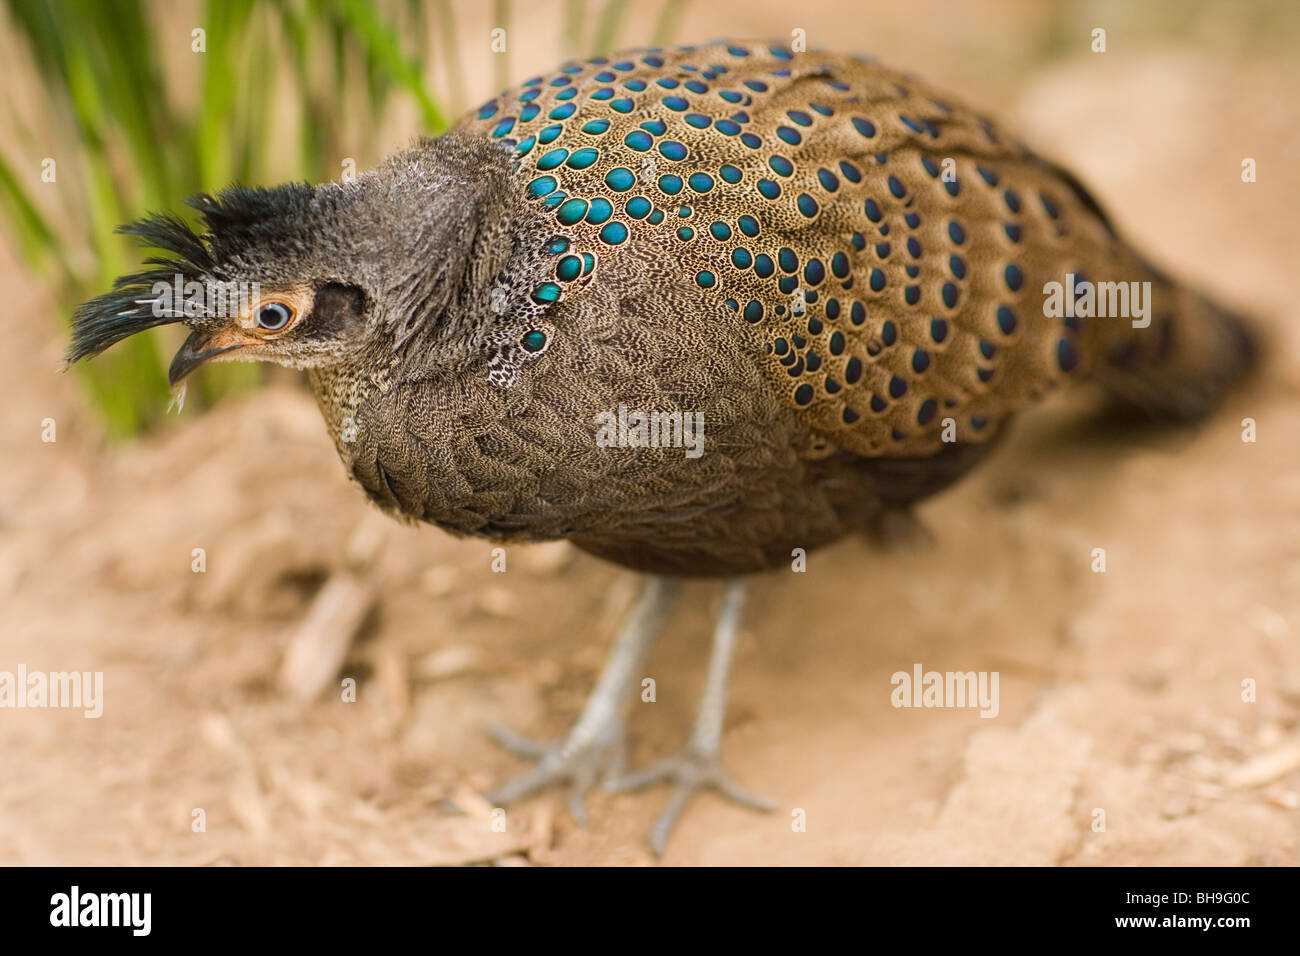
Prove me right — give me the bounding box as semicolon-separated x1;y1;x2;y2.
0;3;1300;865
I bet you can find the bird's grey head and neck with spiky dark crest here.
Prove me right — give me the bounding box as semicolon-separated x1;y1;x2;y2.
68;137;520;385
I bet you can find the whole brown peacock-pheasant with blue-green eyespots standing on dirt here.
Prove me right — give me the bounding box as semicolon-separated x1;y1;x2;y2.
68;40;1258;853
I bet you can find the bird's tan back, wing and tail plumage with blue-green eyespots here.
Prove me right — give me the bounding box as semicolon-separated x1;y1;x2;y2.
459;43;1249;458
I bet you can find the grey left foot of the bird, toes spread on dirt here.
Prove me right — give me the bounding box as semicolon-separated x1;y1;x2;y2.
484;721;627;826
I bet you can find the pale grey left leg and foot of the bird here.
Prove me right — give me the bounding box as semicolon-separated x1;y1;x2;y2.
484;578;681;826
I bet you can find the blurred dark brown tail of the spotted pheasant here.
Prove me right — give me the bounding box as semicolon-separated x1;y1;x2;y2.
1093;280;1258;421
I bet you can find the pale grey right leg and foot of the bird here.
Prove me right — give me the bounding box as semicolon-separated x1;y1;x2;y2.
605;578;776;856
